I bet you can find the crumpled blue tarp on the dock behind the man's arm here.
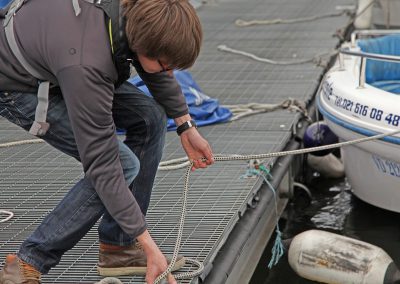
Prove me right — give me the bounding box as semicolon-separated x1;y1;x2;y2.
129;71;232;130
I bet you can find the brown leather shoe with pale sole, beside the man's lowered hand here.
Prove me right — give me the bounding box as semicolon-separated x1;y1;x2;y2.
97;243;185;276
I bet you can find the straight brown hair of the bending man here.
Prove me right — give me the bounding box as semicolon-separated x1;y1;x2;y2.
122;0;203;69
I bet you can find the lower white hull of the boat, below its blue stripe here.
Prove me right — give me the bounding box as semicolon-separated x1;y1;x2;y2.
326;120;400;212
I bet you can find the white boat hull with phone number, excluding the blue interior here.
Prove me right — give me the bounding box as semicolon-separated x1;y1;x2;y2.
317;41;400;212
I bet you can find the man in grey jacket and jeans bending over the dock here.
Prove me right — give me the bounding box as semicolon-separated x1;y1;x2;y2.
0;0;213;284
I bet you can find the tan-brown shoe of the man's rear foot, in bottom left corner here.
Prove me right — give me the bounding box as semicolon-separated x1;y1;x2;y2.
0;254;40;284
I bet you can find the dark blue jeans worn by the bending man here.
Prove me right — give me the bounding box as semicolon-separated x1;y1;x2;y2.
0;83;166;273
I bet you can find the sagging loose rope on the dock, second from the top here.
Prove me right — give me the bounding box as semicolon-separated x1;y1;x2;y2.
217;44;338;65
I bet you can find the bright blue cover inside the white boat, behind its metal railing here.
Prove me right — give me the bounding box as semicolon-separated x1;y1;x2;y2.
358;35;400;94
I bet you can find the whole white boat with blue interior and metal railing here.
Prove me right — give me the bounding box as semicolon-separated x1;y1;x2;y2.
317;30;400;212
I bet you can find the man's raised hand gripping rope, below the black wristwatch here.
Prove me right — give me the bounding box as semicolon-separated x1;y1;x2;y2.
181;127;214;171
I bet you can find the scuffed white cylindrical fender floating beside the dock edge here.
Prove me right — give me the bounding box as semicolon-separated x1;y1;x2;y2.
288;230;397;284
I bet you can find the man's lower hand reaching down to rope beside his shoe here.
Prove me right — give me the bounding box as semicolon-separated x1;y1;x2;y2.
137;230;177;284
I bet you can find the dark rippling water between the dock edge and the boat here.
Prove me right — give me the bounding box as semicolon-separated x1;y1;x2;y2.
250;174;400;284
